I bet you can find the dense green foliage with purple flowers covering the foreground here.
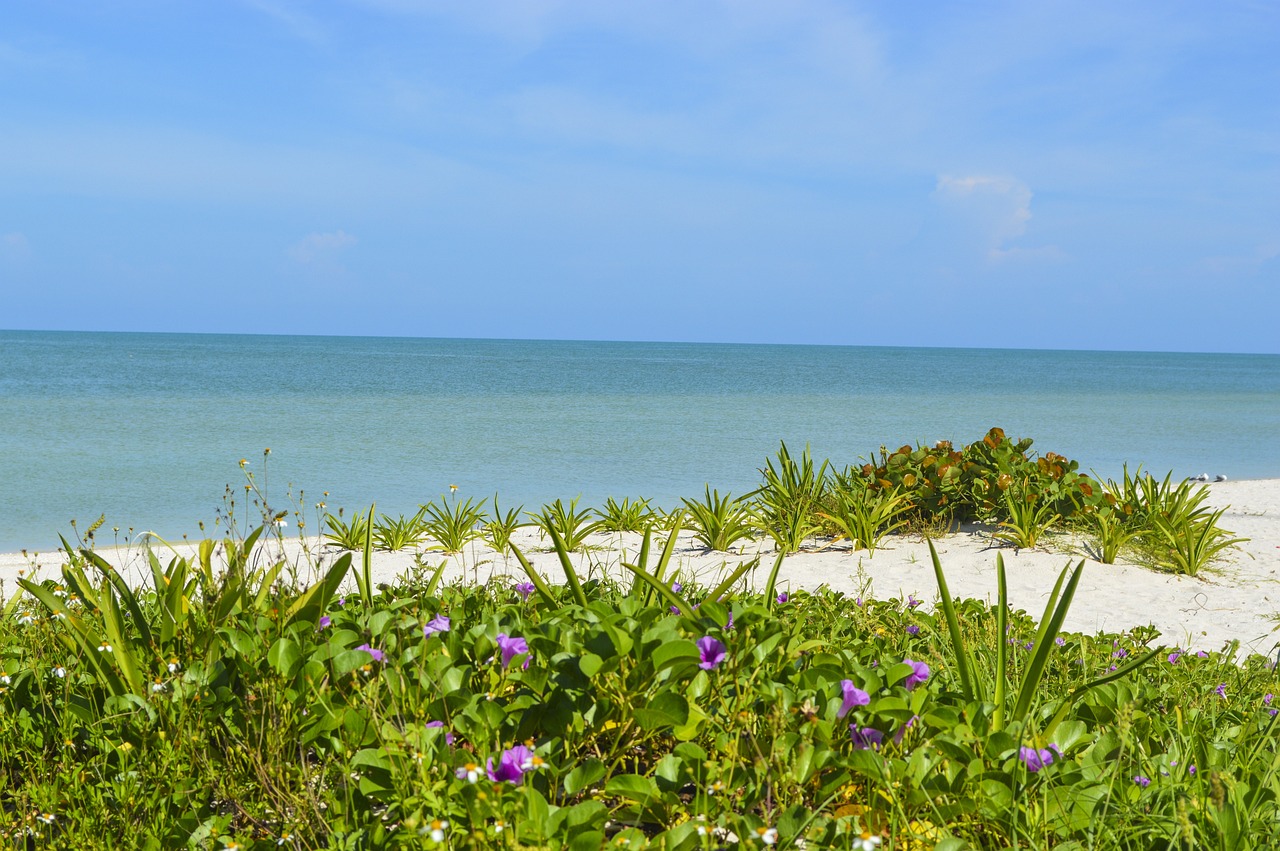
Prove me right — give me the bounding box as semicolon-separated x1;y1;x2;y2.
0;535;1280;850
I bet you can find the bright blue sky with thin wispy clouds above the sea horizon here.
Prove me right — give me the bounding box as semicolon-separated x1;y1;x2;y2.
0;0;1280;353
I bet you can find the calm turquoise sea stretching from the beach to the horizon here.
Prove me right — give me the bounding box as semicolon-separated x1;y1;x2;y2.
0;331;1280;552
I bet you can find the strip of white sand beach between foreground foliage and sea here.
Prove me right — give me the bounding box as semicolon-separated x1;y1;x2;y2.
0;479;1280;655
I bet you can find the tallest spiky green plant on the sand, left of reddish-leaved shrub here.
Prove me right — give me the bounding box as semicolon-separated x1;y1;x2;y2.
751;443;828;553
